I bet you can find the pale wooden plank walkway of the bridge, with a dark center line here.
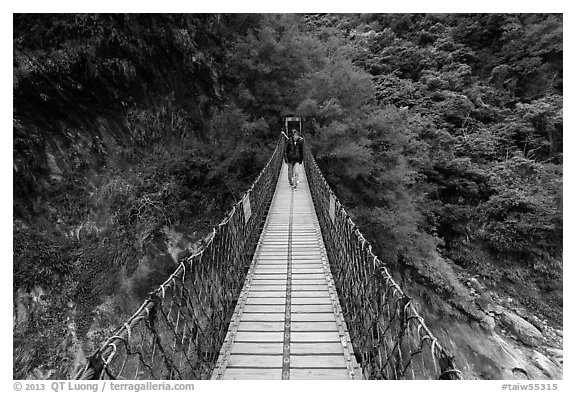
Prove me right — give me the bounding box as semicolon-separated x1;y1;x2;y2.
212;164;361;379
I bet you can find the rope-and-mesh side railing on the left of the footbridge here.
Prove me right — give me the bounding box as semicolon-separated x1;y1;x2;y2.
76;138;284;380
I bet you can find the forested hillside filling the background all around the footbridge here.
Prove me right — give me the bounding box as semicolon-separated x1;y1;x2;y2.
13;14;563;379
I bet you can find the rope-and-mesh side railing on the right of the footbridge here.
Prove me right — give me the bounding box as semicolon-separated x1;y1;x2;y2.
304;142;462;379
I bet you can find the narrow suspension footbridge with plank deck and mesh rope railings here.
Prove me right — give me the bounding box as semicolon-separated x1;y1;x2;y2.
76;138;461;380
